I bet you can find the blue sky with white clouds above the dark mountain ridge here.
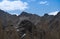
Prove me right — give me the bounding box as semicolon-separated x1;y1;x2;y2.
0;0;60;16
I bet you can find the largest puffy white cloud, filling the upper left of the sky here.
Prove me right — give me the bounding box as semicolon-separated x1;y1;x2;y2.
0;0;28;11
